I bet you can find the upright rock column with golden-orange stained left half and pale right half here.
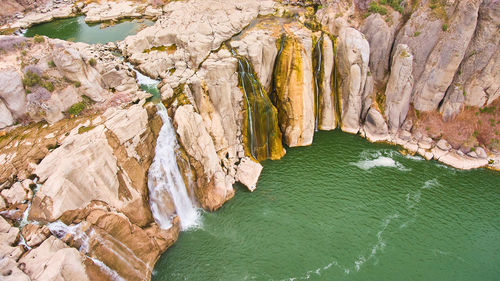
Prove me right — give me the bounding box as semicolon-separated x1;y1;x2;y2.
274;24;315;147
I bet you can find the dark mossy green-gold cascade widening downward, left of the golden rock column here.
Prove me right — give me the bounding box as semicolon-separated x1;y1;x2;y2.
232;50;283;161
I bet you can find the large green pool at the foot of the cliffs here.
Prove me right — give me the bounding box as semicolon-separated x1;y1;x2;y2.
153;131;500;281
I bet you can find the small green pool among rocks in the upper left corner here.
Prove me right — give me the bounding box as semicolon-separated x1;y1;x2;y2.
25;16;154;44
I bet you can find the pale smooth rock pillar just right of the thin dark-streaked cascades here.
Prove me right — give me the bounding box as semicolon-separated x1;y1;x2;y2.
337;27;370;134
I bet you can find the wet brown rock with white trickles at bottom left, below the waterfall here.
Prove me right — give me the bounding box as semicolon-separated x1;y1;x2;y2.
51;206;180;280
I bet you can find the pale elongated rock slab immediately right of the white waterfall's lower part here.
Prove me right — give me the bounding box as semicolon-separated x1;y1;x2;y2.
174;105;234;210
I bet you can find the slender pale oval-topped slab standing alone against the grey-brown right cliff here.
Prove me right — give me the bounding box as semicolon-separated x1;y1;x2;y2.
385;44;413;133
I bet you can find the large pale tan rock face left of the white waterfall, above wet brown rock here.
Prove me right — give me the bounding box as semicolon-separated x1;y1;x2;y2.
30;125;139;221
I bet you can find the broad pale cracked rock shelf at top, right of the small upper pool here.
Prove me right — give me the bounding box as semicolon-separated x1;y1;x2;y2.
120;0;275;77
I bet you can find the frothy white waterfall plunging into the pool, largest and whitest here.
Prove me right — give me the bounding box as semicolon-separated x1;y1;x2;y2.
148;103;199;230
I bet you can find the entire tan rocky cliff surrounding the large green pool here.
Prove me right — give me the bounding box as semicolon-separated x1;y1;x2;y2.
0;0;500;280
